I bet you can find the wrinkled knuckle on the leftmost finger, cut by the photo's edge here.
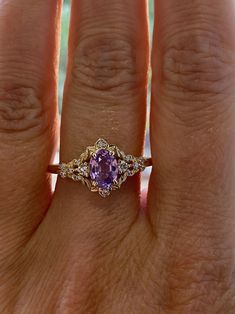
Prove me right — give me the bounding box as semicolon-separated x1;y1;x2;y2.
0;87;48;137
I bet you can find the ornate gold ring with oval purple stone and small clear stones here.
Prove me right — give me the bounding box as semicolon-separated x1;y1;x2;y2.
48;138;152;197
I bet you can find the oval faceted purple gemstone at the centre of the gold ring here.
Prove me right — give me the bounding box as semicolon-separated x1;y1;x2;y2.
90;149;118;189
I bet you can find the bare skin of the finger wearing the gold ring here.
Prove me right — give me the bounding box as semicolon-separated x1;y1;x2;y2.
57;0;148;221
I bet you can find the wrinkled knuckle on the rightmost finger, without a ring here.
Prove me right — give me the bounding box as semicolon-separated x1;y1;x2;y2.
162;26;234;98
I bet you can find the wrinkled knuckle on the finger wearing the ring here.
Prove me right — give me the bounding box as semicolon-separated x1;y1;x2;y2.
72;36;141;94
